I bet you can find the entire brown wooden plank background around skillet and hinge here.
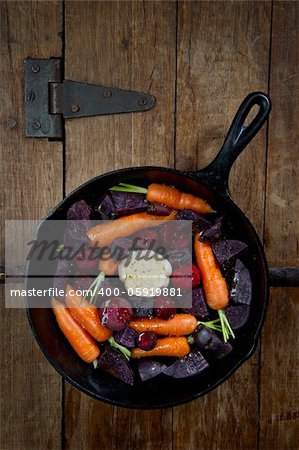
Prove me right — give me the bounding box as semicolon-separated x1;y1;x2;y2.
0;1;299;450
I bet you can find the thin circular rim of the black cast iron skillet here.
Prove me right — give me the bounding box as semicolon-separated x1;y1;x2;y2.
25;166;270;409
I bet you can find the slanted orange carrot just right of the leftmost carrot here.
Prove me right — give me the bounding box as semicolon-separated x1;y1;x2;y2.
65;286;112;342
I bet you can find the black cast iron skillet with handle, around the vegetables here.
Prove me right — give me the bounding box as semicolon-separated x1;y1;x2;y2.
26;92;271;408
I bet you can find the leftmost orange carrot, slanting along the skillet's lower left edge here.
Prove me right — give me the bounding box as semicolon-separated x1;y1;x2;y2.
51;298;100;363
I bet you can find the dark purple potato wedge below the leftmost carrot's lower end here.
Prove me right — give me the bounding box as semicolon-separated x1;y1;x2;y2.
98;347;134;386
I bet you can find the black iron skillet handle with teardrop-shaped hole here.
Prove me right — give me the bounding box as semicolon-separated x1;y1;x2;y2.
189;92;271;196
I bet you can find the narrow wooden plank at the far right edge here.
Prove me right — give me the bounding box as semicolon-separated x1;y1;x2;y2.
260;2;299;450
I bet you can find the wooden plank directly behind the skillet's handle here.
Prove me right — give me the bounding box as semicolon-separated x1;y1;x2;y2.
173;2;271;450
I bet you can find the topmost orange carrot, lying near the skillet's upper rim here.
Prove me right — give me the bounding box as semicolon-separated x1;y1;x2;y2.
146;183;213;213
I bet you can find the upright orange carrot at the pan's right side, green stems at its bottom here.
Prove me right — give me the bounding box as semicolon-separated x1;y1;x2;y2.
194;234;229;309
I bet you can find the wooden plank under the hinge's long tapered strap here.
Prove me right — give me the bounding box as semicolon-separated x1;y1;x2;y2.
65;1;176;450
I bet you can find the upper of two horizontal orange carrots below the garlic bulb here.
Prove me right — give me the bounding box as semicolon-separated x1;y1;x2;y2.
129;314;197;336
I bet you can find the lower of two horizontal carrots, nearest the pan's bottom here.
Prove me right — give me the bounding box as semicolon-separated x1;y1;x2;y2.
131;337;190;358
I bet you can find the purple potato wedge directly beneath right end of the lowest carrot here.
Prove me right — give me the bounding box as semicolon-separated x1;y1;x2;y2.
162;350;209;378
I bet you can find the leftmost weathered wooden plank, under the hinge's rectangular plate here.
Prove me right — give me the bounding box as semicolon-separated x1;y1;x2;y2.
0;1;62;450
